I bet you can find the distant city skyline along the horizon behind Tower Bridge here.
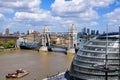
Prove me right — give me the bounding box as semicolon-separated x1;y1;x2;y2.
0;27;100;35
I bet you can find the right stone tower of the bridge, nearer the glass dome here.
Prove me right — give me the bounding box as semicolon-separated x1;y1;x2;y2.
67;24;77;53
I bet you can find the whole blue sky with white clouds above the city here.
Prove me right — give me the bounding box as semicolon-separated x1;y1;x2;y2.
0;0;120;33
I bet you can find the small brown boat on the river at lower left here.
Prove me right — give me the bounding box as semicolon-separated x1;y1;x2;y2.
6;69;29;78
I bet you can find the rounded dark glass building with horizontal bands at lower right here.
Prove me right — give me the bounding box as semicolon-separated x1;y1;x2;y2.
70;33;120;80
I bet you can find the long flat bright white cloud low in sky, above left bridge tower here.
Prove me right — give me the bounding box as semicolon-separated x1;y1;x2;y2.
14;10;61;22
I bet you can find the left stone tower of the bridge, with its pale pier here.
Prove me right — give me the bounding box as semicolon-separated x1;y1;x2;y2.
39;25;50;51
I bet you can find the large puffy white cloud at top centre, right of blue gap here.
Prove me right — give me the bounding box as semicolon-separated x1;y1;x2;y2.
51;0;92;19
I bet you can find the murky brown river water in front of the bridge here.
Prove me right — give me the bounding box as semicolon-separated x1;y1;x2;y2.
0;50;74;80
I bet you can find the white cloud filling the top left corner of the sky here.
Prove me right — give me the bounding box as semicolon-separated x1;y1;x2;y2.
0;0;41;12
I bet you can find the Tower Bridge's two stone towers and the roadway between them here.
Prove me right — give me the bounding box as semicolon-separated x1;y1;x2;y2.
32;24;78;53
